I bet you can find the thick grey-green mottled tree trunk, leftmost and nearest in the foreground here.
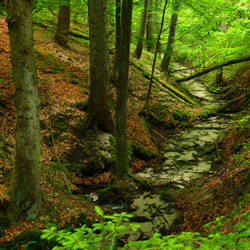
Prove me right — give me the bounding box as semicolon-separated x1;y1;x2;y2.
7;0;41;220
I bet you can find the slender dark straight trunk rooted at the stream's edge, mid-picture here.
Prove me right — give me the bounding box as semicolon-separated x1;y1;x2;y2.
116;0;133;179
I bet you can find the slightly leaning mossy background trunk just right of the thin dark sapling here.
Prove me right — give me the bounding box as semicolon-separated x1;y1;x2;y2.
161;0;180;72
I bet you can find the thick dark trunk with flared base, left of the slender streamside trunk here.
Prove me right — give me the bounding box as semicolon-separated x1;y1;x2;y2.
84;0;114;132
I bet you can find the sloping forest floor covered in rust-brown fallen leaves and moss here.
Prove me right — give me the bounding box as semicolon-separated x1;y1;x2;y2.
0;18;250;247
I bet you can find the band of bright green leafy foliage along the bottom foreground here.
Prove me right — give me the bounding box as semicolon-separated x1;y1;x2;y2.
41;207;250;250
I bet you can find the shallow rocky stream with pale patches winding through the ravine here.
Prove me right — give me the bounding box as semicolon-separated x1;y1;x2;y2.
117;64;233;241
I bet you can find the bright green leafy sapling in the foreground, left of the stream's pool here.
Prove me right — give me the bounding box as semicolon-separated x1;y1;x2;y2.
41;207;138;250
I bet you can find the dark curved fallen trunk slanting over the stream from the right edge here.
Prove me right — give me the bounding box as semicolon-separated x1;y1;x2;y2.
176;56;250;82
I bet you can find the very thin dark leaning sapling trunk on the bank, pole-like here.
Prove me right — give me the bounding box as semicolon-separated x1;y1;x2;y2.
145;0;168;108
